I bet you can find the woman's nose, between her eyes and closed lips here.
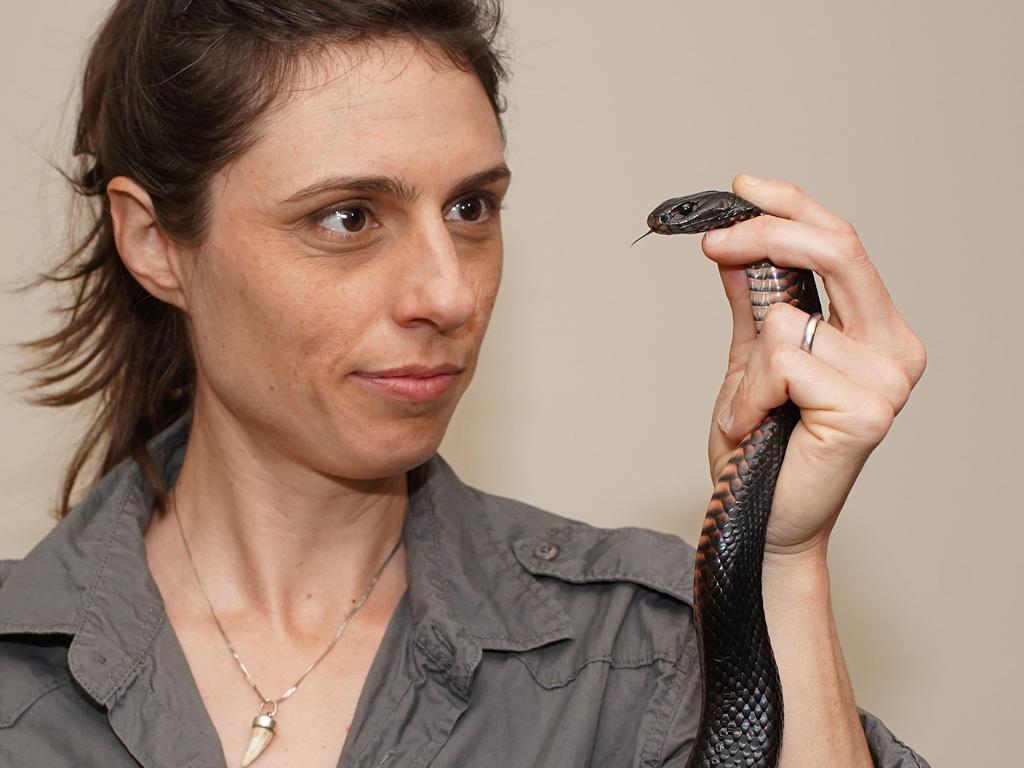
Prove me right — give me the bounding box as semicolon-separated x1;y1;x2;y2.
396;221;476;331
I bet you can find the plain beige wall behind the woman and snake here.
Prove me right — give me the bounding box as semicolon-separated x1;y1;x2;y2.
0;0;1024;766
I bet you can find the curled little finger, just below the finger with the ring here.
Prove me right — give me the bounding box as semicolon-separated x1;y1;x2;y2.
722;337;895;452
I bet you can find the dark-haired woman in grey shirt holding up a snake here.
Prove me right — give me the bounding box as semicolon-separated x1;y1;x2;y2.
0;0;925;768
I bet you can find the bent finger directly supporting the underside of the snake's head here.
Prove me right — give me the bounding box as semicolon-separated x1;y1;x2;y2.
701;215;901;335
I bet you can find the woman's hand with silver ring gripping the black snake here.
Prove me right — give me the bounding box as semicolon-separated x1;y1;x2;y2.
701;174;926;556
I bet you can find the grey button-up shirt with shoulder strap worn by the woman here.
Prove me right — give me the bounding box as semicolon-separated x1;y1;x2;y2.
0;414;927;768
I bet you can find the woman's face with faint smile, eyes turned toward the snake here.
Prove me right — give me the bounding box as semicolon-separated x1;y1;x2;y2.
186;42;508;479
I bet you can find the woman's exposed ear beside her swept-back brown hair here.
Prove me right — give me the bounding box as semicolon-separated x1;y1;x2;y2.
106;176;187;310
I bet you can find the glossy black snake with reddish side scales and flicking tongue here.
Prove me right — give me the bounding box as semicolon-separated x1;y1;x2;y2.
634;190;821;768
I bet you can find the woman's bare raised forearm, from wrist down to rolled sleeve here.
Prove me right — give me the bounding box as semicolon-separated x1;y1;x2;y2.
763;549;873;768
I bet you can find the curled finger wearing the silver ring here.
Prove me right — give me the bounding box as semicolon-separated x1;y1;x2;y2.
748;303;913;414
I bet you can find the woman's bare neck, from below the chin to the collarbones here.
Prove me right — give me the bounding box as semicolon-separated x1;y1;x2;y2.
144;403;409;637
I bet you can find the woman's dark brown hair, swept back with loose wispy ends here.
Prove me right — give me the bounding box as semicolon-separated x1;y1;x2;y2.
12;0;507;518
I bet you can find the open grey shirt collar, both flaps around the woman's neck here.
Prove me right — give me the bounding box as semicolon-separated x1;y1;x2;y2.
0;411;574;703
